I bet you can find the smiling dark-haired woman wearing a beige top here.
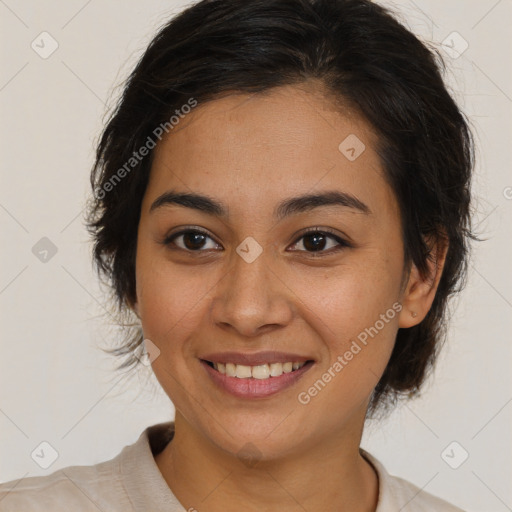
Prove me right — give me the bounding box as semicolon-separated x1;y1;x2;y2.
0;0;473;512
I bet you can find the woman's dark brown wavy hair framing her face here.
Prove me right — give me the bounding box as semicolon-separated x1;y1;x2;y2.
86;0;476;412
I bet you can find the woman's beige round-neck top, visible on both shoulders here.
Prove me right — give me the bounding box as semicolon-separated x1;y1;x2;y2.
0;422;463;512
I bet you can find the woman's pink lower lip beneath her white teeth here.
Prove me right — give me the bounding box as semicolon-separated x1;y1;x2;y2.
201;361;314;398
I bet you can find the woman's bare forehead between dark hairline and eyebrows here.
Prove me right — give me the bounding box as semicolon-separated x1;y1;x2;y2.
147;86;393;220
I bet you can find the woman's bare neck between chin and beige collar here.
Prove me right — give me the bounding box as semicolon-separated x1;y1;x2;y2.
155;411;379;512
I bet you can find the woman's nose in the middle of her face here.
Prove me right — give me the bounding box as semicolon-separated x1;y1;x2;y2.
210;245;294;338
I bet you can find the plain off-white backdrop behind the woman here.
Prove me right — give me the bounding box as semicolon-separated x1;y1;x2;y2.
0;0;512;512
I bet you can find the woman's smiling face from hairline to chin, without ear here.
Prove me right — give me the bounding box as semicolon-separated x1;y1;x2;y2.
135;86;410;458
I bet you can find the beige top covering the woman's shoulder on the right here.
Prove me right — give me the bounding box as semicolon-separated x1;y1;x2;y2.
361;449;464;512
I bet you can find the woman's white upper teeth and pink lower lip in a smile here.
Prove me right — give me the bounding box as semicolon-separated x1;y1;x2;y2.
200;358;315;399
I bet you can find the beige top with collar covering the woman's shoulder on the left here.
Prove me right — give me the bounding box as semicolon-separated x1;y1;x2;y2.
0;422;177;512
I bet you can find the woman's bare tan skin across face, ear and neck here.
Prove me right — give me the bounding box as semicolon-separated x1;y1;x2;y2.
133;83;445;512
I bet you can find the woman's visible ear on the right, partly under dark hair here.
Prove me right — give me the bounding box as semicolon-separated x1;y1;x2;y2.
398;235;448;328
